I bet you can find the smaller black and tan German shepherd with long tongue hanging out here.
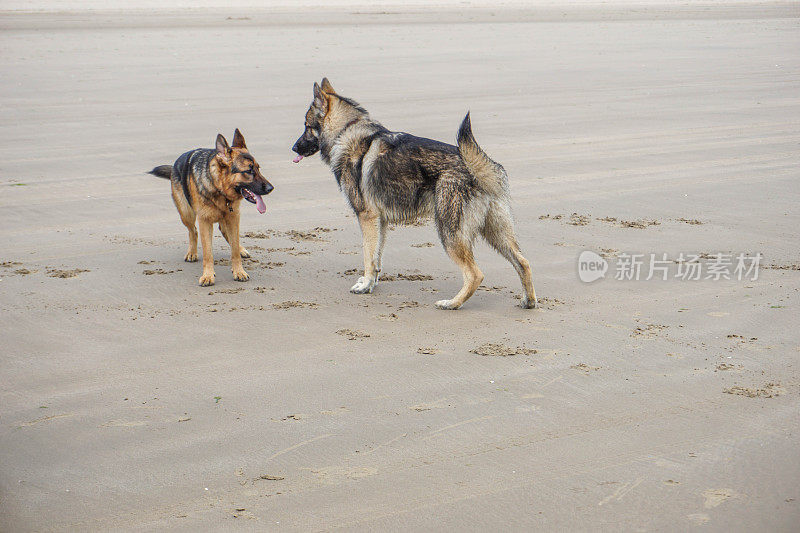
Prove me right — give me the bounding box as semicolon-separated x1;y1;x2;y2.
149;129;273;287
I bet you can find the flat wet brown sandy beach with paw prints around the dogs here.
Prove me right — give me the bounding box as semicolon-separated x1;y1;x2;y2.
0;2;800;532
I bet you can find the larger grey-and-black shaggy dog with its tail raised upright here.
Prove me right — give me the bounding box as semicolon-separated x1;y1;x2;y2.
292;78;538;309
